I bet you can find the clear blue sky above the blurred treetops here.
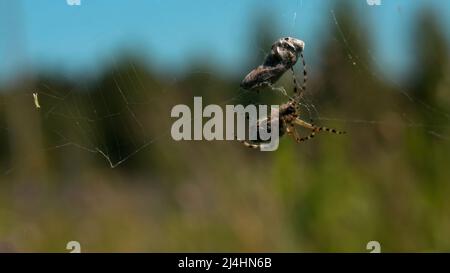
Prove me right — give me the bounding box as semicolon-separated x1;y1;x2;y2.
0;0;450;84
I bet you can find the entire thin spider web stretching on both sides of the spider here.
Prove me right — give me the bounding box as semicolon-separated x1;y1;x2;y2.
0;0;450;174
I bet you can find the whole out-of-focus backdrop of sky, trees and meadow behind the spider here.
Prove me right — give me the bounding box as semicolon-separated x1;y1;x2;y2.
0;0;450;252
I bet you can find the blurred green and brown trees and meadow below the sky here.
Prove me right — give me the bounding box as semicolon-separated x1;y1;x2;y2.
0;5;450;252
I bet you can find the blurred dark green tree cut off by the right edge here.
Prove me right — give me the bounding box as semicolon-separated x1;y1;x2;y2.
406;9;450;202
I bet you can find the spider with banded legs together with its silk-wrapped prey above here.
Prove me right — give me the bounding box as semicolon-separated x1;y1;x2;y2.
238;37;345;149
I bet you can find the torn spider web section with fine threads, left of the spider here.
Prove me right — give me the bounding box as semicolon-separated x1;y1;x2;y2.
29;64;248;169
